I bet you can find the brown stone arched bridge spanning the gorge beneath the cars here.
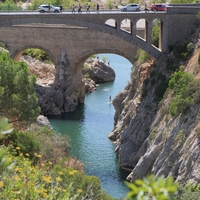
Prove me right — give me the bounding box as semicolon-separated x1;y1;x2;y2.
0;5;200;112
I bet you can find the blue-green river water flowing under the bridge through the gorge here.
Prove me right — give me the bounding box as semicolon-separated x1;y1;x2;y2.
48;54;132;199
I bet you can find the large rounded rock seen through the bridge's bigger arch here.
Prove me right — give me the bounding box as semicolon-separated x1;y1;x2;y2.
83;59;115;83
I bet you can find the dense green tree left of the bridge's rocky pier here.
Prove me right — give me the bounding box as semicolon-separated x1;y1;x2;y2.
0;52;40;126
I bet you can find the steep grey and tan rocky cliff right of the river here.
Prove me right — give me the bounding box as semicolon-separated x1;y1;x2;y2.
108;31;200;183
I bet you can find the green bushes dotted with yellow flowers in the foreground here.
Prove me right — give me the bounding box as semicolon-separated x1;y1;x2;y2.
0;118;113;200
